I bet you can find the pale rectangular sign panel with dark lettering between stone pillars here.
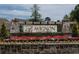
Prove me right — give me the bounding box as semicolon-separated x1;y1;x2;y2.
23;25;57;33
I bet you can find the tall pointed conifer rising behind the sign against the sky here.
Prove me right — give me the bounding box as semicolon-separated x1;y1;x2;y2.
31;4;41;21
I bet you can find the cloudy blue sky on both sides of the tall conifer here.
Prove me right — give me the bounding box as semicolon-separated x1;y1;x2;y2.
0;4;75;20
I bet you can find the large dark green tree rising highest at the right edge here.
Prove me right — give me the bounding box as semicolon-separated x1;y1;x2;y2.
70;4;79;34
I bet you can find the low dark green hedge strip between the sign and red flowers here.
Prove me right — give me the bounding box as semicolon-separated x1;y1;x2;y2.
11;33;64;36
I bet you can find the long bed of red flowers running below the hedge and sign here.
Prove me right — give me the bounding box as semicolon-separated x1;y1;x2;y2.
10;35;79;40
